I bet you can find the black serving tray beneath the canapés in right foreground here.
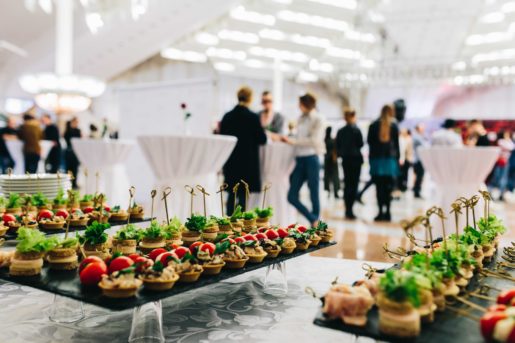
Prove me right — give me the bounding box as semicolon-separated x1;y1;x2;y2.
314;259;513;343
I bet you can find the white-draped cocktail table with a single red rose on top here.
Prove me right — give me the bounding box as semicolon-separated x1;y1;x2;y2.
138;135;237;220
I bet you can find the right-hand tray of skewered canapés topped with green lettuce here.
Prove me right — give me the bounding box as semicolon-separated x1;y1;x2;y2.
315;192;515;342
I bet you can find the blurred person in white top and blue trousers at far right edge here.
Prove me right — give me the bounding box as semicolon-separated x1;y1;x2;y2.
492;131;515;201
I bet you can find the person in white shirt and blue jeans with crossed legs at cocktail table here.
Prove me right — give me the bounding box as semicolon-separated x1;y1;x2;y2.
282;93;325;226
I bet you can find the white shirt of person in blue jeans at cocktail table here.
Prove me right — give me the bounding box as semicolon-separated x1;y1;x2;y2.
293;111;325;157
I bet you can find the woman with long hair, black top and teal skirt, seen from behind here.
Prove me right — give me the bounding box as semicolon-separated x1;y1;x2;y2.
367;105;400;221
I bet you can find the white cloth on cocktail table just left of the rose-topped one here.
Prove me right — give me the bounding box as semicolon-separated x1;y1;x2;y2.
72;138;135;208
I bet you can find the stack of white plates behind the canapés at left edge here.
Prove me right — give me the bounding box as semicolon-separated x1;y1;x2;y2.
0;174;72;199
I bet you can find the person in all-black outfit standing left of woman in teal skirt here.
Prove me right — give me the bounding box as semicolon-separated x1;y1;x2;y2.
336;109;363;219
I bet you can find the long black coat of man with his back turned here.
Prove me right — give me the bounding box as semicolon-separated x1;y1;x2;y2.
220;105;266;192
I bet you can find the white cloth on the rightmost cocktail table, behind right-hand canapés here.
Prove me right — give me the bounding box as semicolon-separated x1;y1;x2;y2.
418;147;499;235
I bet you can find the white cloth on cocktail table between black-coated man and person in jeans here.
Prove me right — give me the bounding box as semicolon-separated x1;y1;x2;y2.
249;143;296;225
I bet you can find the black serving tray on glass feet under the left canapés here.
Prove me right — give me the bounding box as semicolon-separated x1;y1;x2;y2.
0;242;336;310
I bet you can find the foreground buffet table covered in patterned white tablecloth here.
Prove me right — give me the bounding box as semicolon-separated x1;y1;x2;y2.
0;256;388;343
